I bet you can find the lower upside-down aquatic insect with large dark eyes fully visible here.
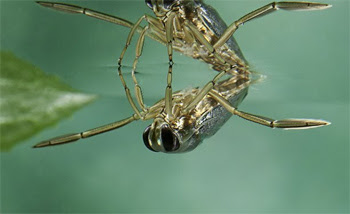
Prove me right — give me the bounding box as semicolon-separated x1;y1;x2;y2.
34;72;329;153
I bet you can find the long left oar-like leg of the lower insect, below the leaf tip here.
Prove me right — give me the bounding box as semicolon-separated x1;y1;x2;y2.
33;115;140;148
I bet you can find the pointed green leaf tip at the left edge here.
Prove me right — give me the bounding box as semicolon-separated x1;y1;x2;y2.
0;52;96;151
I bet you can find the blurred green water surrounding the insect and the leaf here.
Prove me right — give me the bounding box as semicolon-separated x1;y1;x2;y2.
0;0;349;213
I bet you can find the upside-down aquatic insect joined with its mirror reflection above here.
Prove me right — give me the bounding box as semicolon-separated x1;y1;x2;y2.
34;0;330;153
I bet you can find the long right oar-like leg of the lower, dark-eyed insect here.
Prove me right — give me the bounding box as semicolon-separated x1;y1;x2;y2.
209;90;330;129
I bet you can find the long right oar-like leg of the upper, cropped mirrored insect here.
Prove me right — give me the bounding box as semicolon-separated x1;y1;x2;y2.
214;2;331;50
